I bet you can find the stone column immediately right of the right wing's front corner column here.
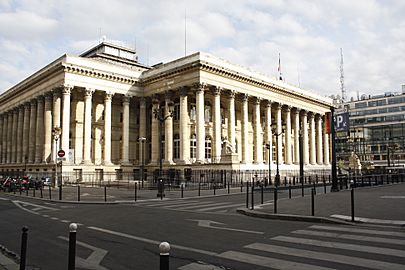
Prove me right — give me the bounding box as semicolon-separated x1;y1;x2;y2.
213;87;222;162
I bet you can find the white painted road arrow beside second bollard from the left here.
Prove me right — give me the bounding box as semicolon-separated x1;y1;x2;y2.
58;236;108;270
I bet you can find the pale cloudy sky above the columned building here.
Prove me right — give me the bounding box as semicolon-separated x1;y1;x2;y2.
0;0;405;98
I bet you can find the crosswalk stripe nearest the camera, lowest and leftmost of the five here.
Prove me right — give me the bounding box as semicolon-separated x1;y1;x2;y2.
218;251;334;270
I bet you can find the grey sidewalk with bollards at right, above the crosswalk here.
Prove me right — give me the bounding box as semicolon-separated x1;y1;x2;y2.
238;183;405;227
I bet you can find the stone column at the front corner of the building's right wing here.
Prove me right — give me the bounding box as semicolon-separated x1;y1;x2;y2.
196;84;206;164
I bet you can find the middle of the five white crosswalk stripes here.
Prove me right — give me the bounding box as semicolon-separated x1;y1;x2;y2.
271;236;405;258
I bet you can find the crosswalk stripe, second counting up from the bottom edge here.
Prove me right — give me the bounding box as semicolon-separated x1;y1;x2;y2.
245;243;404;270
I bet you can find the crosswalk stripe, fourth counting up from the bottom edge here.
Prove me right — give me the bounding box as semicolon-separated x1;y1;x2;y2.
292;230;405;245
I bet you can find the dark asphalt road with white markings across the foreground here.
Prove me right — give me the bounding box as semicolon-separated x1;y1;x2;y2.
0;191;405;270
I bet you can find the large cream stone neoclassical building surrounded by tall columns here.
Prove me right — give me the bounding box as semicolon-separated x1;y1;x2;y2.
0;42;332;178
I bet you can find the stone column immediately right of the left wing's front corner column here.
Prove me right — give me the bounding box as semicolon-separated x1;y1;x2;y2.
83;88;94;164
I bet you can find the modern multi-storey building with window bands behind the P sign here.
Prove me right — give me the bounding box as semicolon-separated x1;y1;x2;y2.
336;85;405;170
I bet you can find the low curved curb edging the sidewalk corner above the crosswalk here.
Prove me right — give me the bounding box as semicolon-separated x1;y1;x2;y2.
236;208;361;225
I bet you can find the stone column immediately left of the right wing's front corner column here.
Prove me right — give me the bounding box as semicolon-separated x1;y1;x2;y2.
180;88;190;164
